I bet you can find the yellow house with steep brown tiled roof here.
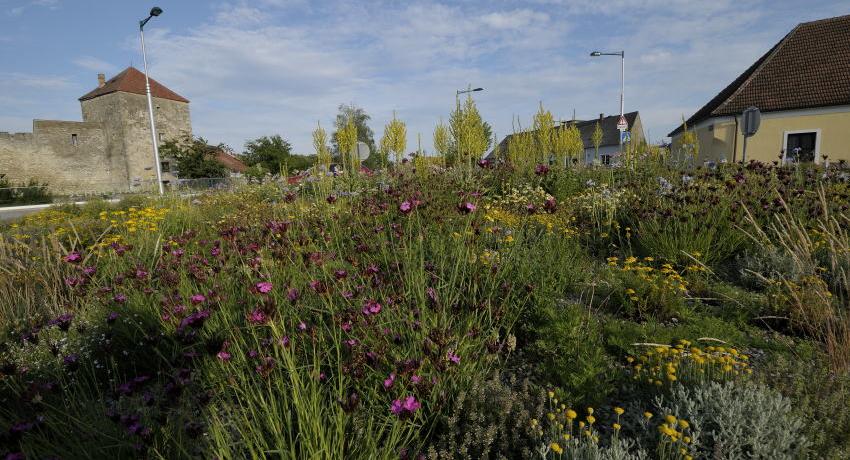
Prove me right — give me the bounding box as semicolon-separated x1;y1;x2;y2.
669;15;850;163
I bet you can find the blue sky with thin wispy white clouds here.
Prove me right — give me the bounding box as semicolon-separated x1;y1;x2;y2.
0;0;850;154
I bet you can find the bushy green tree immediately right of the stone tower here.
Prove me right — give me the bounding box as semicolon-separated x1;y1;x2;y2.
159;137;231;179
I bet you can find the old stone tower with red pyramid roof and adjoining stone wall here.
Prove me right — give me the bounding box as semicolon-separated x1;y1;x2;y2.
0;67;192;194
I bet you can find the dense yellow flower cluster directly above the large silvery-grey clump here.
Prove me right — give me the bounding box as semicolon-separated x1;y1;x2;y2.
626;340;752;386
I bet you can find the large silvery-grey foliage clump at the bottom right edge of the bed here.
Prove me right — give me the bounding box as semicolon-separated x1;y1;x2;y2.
655;382;809;460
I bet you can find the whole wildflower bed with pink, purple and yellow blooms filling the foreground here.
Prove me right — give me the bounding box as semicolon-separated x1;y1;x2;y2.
0;149;850;459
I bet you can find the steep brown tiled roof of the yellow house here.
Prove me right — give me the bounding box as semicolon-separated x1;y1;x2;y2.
669;15;850;136
